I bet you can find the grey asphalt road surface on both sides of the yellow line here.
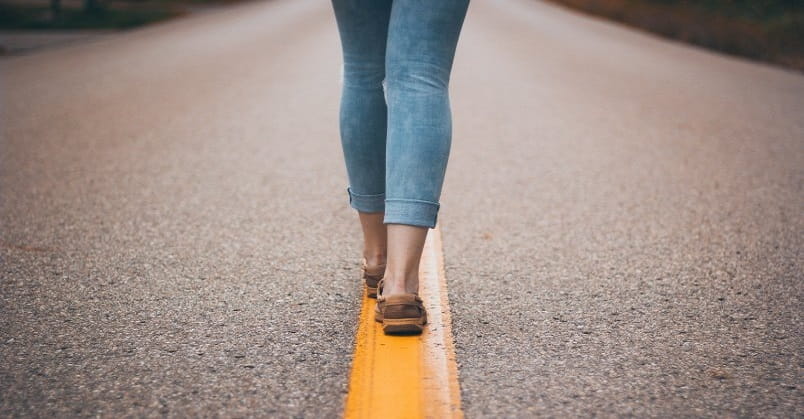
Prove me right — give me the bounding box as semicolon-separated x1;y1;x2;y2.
0;0;804;417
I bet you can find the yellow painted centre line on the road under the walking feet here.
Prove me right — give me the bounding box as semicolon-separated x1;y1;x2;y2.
344;226;463;419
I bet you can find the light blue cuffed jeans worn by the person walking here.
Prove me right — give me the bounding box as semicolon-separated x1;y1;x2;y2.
332;0;469;228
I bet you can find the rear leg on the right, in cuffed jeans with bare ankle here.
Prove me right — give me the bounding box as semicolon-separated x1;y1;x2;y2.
383;0;469;295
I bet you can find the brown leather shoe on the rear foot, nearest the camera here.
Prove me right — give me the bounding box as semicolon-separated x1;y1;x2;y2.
374;284;427;335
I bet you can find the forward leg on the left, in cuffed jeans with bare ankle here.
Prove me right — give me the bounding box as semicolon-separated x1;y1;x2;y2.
332;0;391;273
